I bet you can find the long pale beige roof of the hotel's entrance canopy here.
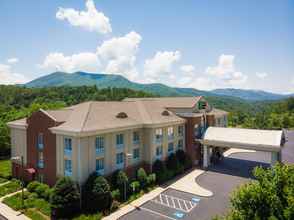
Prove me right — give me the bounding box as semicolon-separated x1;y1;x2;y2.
201;127;285;152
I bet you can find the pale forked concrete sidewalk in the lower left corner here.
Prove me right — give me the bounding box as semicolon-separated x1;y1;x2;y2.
0;191;31;220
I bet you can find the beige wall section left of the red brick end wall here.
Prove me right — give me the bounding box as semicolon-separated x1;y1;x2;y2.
10;128;27;165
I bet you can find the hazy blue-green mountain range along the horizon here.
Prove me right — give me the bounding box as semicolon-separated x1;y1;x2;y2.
24;72;294;101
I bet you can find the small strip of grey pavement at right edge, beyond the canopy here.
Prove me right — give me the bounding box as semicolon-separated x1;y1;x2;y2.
282;131;294;164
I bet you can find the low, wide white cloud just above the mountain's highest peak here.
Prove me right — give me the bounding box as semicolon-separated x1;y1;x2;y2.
40;52;100;72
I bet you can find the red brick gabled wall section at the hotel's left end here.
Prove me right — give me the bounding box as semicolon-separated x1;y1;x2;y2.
27;111;57;186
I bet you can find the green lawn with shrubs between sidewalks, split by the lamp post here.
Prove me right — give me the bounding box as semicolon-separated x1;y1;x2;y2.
3;192;51;220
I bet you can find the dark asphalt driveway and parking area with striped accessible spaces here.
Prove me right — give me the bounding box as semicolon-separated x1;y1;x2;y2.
120;152;271;220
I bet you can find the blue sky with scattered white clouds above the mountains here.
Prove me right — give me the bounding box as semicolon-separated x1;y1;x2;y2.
0;0;294;93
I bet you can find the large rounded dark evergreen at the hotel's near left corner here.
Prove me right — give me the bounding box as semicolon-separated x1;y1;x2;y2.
50;177;80;218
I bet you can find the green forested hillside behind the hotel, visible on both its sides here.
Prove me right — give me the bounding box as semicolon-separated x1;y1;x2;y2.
0;85;294;156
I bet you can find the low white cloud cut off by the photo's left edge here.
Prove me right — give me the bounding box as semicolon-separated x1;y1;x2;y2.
0;64;29;85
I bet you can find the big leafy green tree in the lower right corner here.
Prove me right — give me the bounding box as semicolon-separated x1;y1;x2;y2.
225;164;294;220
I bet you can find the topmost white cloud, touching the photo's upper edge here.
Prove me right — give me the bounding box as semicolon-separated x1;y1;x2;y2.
56;0;112;34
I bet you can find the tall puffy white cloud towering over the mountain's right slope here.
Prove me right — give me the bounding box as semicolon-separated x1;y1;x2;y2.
97;31;142;80
